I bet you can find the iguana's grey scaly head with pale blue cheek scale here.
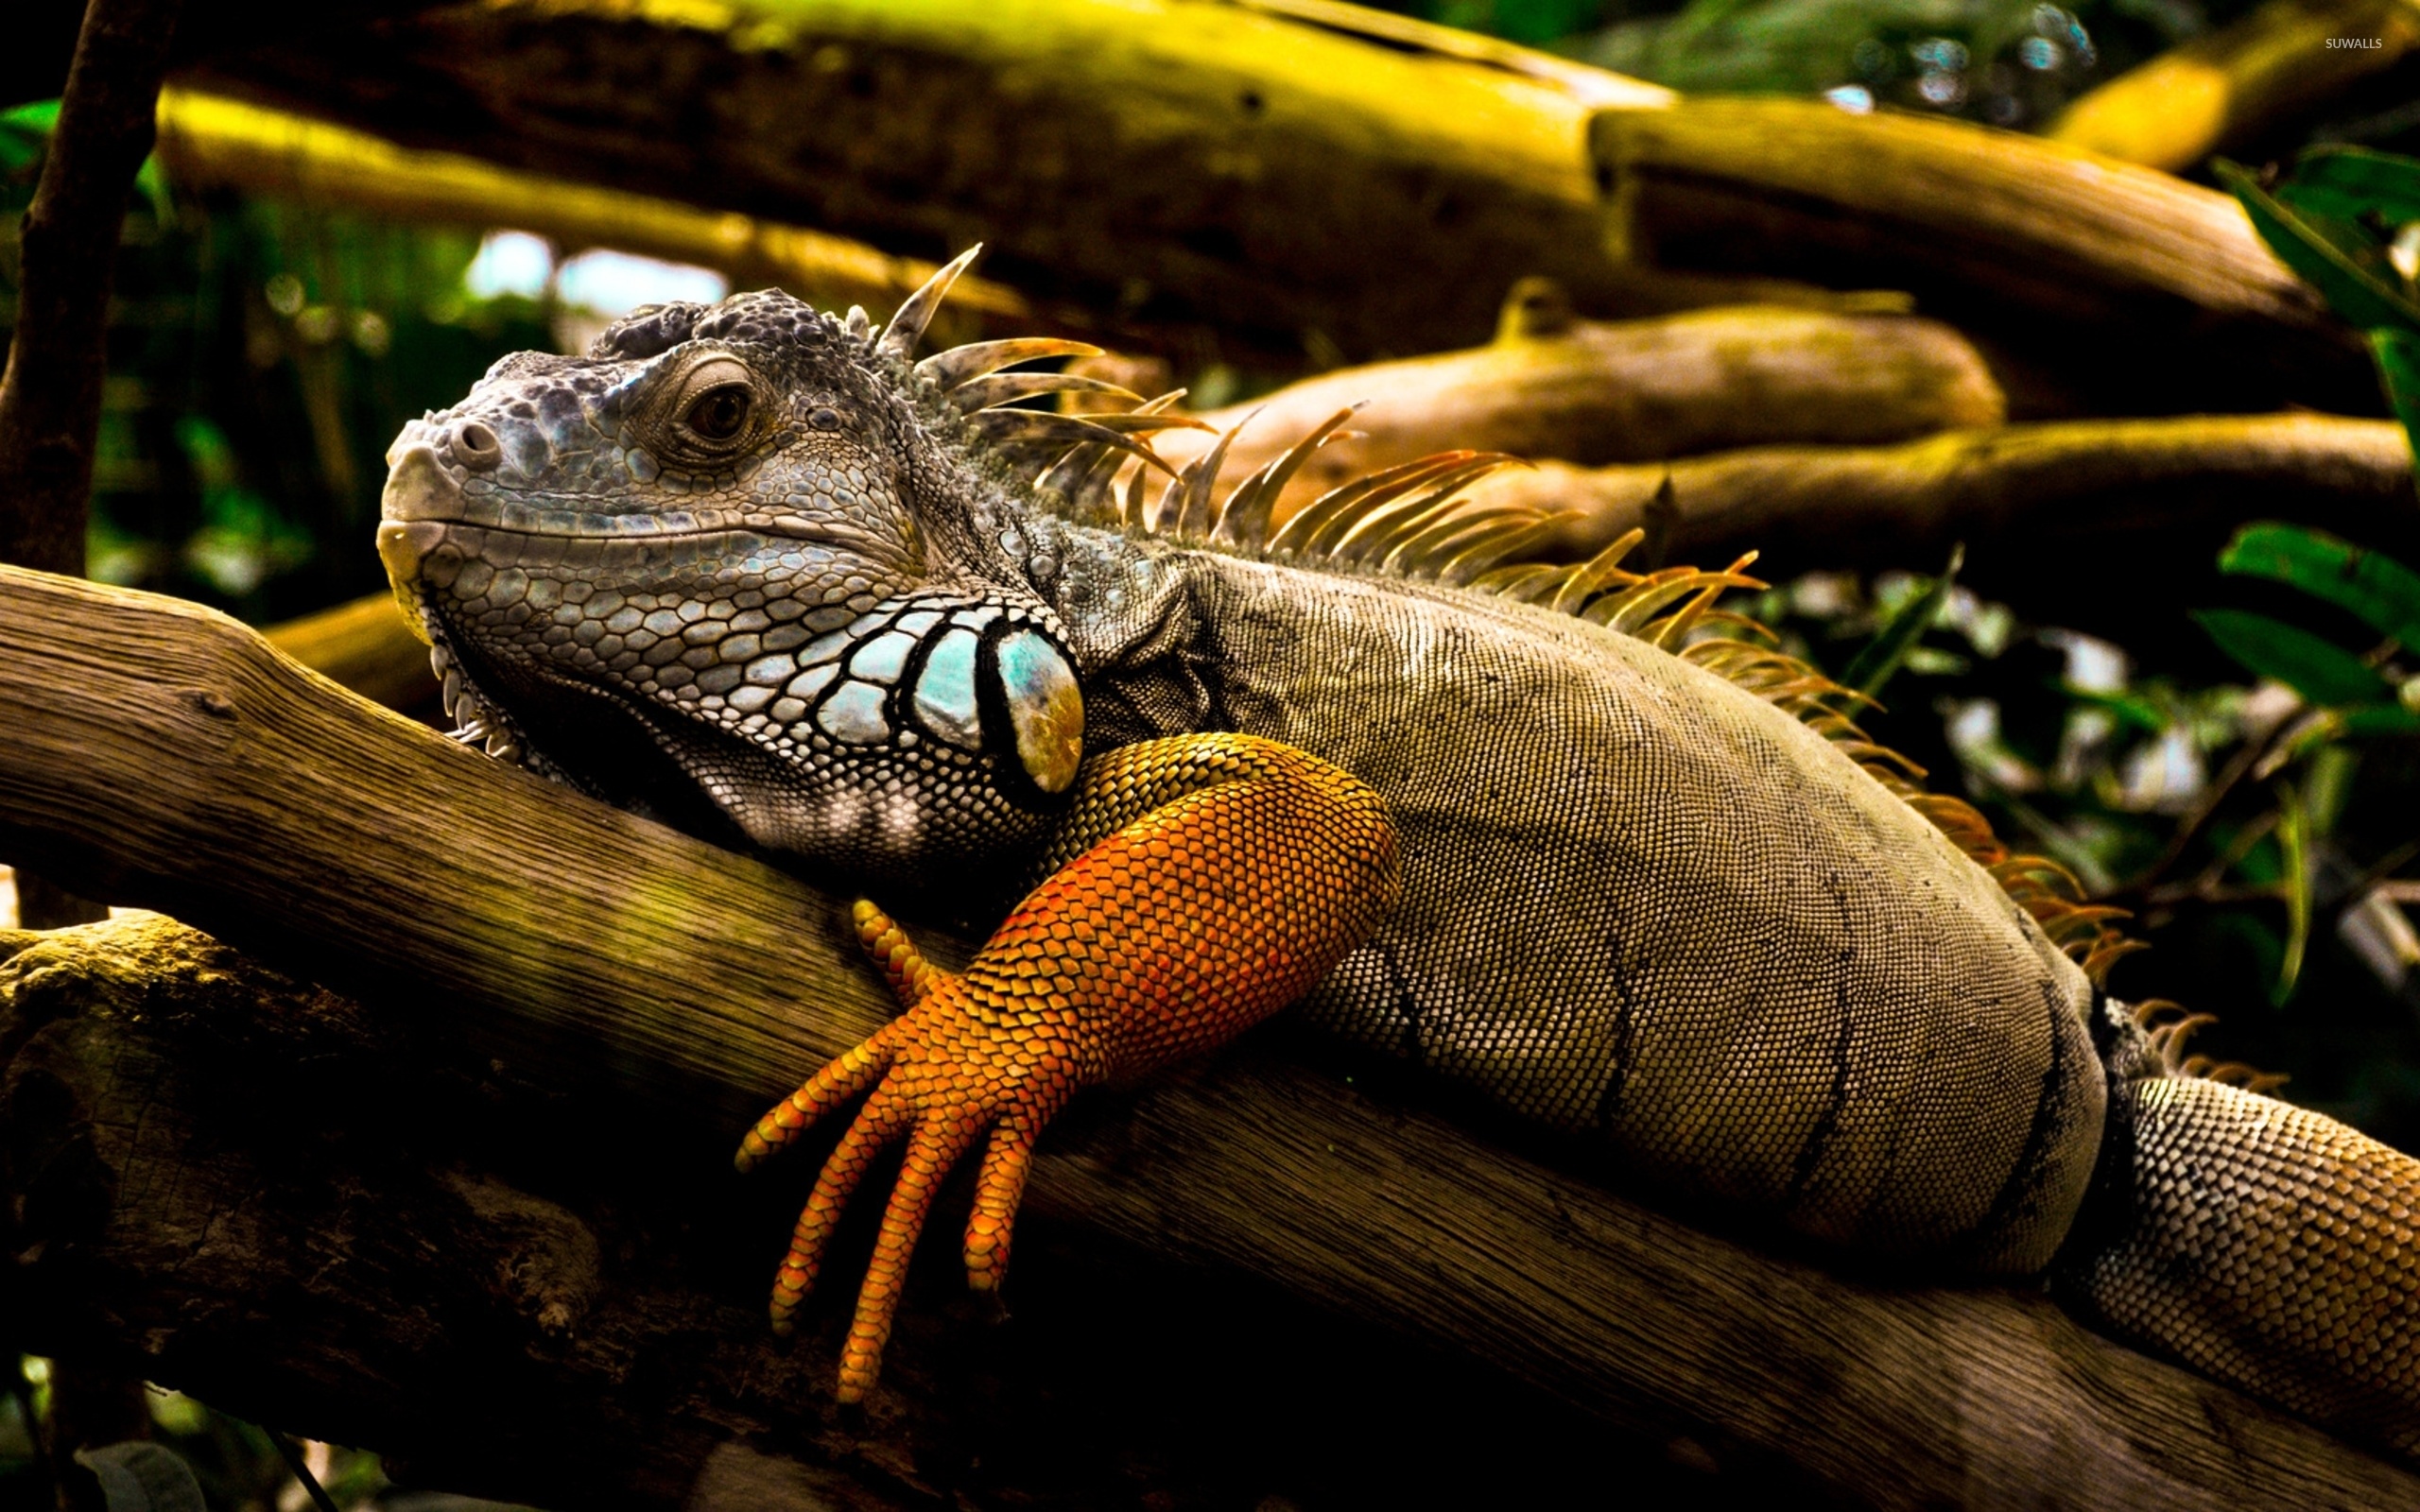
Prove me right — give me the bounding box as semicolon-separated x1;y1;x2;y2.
377;259;1113;876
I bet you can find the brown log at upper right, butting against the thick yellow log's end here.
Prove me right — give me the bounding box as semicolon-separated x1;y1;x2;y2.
1590;99;2384;414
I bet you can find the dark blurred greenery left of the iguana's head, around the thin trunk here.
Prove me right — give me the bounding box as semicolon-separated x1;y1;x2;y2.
0;104;552;619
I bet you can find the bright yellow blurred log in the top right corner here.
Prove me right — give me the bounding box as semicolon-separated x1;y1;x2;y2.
2045;0;2420;172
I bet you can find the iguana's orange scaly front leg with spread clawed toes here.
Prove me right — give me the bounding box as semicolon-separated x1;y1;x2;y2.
738;735;1396;1400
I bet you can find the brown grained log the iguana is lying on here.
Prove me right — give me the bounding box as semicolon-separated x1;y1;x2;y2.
0;571;2420;1507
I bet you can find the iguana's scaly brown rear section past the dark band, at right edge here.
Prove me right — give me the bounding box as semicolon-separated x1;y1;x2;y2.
2052;1076;2420;1454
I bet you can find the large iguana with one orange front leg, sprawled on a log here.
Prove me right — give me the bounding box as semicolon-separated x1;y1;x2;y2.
377;254;2420;1454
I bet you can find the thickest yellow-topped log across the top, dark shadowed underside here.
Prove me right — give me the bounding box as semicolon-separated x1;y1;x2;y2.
170;0;1916;370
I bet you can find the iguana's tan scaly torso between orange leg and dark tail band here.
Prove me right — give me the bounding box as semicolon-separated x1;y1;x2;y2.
1058;549;2103;1270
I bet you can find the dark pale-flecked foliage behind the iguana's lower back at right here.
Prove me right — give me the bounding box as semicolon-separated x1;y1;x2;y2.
1750;512;2420;1146
